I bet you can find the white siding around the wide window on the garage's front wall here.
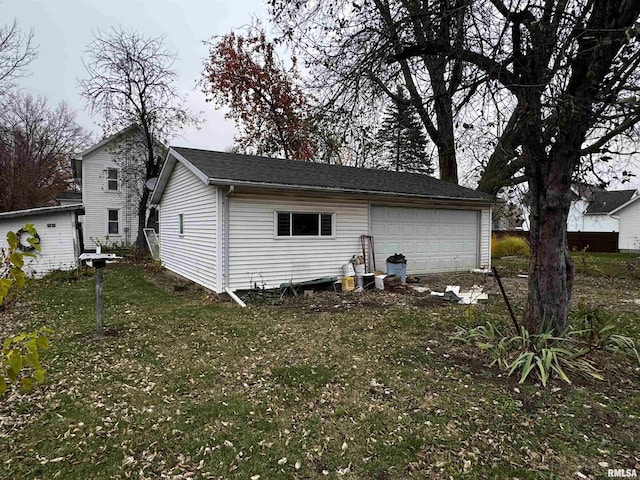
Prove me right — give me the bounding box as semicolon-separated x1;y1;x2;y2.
229;193;369;290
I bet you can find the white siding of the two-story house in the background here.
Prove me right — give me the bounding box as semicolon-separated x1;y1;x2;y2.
82;145;139;249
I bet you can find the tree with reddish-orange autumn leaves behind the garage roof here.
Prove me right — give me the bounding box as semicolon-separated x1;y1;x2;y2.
203;24;314;160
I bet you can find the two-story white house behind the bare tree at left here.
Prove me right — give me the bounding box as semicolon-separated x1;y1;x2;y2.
74;127;152;250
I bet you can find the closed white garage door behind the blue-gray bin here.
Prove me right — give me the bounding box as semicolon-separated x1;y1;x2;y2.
371;206;480;274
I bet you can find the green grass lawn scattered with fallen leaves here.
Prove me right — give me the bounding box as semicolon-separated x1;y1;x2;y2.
0;255;640;480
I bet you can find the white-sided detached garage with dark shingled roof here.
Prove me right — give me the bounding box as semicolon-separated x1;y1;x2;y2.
152;148;492;292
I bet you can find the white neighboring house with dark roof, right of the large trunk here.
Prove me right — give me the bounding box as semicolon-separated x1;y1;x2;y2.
567;185;636;232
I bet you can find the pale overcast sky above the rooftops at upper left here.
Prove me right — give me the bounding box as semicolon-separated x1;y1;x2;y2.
0;0;266;150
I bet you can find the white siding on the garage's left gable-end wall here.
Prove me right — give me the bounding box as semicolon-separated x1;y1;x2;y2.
160;162;220;292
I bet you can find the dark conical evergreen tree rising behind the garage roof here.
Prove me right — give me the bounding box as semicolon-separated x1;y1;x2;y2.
377;87;434;175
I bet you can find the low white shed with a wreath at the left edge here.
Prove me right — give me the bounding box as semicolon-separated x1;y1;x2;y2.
0;204;83;278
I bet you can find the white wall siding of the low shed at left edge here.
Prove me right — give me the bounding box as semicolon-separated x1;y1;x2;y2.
0;211;80;278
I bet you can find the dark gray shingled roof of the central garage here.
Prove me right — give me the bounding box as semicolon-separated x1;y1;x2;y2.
172;147;492;202
